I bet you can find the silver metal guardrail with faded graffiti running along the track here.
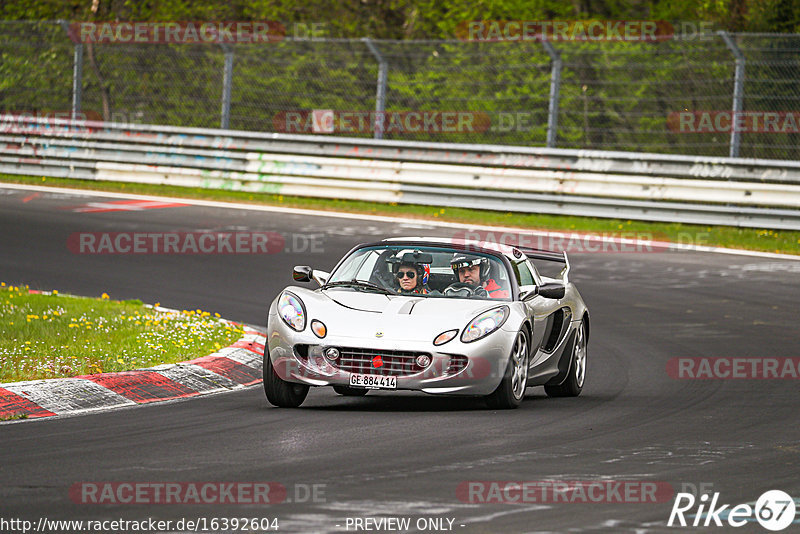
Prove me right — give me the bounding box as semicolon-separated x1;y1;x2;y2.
0;117;800;230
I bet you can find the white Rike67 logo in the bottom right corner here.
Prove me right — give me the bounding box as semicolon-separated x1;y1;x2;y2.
667;490;797;532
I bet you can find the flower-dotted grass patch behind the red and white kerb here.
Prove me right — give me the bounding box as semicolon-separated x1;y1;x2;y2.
0;282;242;383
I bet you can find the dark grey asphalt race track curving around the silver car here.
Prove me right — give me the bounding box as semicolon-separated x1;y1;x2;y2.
0;187;800;533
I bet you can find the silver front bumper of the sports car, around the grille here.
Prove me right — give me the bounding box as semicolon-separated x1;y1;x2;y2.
267;314;514;395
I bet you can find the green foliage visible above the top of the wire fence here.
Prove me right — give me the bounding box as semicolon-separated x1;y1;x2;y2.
0;0;800;35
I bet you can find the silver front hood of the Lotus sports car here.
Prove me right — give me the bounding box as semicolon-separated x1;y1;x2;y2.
292;288;504;341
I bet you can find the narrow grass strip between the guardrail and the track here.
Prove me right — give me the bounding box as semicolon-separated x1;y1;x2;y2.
0;174;800;254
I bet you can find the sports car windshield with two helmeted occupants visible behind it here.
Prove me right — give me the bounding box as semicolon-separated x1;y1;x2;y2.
323;245;511;300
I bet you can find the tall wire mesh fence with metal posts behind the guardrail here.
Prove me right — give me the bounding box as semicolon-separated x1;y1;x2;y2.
0;22;800;160
